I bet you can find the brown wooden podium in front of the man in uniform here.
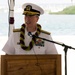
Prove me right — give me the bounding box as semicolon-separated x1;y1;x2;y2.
1;54;61;75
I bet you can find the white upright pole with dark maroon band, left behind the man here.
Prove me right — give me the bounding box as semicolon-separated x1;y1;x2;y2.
8;0;15;36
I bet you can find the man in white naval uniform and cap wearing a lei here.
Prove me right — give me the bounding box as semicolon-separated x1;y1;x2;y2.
2;3;58;55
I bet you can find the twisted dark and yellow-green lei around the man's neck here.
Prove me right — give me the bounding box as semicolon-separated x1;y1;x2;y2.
20;24;41;51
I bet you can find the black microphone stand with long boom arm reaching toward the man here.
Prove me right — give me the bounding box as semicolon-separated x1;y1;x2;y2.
29;33;75;75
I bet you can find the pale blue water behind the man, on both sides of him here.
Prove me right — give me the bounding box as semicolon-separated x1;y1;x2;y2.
0;13;75;36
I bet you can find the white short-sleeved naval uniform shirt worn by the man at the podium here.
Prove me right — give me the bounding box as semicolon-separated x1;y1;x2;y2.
2;30;57;55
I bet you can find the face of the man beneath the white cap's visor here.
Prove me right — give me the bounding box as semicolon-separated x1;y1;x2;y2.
24;15;39;27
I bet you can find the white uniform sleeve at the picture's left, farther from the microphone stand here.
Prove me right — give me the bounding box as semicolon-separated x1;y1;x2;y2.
2;35;15;55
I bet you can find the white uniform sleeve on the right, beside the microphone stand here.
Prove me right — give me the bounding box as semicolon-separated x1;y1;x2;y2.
46;35;58;54
